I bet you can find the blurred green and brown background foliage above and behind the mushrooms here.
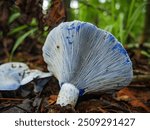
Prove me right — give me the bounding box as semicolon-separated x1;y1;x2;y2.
0;0;150;60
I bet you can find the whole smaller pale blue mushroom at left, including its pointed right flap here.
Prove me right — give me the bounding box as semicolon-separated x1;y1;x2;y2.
0;62;52;92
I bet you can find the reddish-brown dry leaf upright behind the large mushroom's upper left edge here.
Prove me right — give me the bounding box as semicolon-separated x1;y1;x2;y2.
45;0;66;28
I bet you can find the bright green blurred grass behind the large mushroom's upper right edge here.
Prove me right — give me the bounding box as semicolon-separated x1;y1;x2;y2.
72;0;146;44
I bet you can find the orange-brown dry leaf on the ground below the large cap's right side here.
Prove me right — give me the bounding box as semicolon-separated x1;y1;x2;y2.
116;87;150;112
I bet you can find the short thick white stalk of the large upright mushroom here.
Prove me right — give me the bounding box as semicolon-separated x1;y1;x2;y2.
56;83;79;107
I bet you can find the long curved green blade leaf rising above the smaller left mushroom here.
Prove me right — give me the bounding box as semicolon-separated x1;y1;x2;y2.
10;28;37;60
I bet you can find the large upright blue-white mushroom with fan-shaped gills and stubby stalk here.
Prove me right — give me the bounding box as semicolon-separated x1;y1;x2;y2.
43;21;133;106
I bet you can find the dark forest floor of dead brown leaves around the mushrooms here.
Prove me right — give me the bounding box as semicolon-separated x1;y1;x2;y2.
0;42;150;113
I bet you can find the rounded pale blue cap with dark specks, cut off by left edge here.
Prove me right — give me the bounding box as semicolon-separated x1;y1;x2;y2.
0;62;29;90
